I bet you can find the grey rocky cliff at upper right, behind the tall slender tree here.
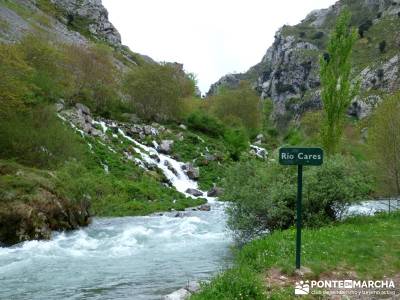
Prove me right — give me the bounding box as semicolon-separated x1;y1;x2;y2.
209;0;400;123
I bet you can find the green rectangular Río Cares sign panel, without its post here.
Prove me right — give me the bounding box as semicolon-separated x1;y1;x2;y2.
279;148;324;166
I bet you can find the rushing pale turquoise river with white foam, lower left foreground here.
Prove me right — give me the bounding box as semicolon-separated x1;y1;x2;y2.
0;205;231;299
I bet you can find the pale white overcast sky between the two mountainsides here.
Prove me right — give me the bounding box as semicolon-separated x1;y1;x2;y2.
103;0;336;93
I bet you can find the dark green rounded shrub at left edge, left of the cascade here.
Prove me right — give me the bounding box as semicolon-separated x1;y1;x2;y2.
0;106;83;168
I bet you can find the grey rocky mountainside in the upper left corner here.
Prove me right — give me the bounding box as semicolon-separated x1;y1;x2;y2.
0;0;121;47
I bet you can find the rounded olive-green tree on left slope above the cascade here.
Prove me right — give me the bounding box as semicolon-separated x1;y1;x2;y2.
124;64;194;121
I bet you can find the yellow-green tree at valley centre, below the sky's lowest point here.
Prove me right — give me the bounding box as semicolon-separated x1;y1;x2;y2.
208;82;262;134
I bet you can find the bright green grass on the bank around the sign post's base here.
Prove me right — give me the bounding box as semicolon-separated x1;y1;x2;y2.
191;212;400;300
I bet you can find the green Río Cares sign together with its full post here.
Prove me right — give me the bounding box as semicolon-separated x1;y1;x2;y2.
279;148;324;269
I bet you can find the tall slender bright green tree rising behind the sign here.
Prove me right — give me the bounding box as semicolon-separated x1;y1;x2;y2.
320;10;359;155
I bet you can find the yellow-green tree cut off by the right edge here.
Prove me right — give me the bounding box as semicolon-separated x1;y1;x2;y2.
368;94;400;195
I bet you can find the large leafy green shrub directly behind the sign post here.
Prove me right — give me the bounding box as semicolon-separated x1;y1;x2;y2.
222;156;373;241
